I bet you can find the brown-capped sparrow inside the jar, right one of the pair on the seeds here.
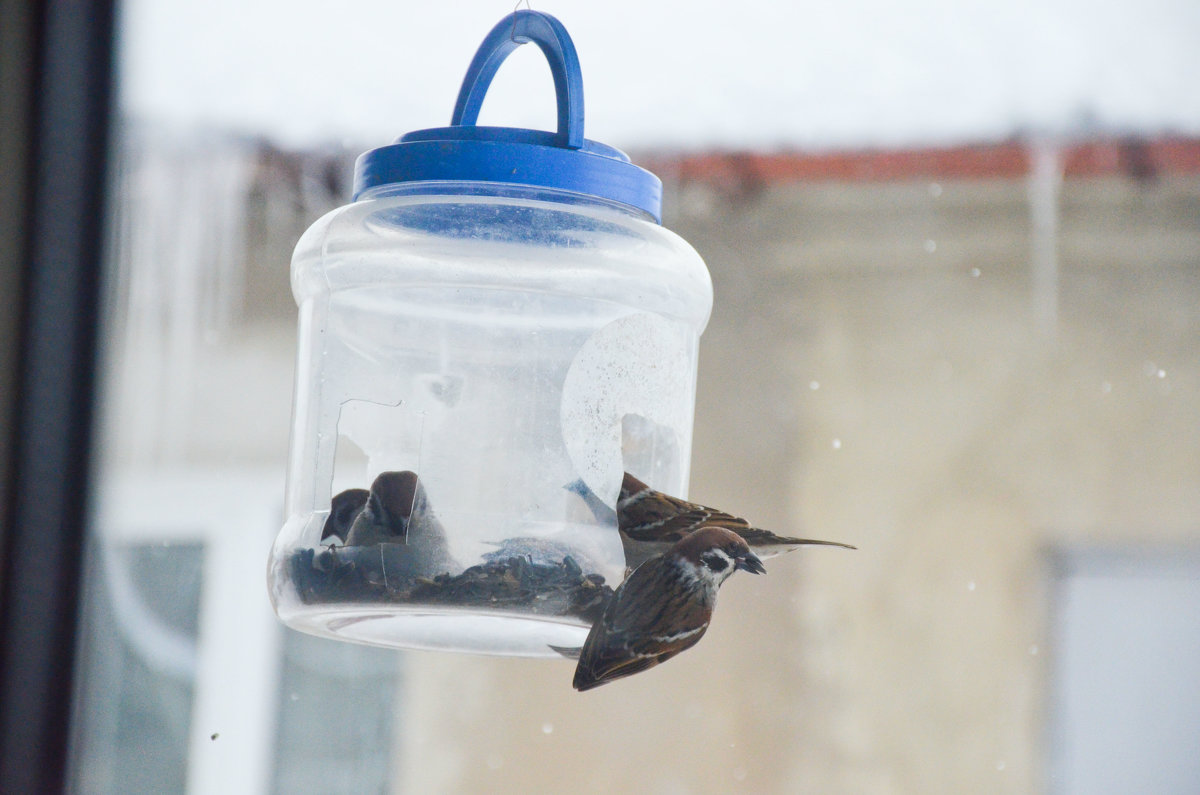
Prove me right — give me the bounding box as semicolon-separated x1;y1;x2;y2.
350;470;455;575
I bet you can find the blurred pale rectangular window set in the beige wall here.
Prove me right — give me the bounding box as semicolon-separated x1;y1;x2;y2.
1051;551;1200;795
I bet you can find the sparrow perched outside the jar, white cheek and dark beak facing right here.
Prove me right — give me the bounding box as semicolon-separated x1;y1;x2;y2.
572;527;767;691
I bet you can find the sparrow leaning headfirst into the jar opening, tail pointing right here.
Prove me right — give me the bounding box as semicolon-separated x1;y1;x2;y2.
566;472;854;568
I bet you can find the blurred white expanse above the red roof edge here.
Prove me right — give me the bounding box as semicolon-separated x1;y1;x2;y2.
120;0;1200;150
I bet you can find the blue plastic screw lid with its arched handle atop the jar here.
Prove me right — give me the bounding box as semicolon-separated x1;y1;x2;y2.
354;11;662;223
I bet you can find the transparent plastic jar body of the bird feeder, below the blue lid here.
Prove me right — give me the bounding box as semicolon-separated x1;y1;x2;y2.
269;184;712;656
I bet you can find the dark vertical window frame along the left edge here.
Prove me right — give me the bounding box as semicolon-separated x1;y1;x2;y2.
0;0;115;793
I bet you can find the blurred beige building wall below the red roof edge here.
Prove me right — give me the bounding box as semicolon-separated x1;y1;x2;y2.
397;171;1200;793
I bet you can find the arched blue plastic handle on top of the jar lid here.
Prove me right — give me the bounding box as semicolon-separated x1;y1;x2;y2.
450;11;583;149
